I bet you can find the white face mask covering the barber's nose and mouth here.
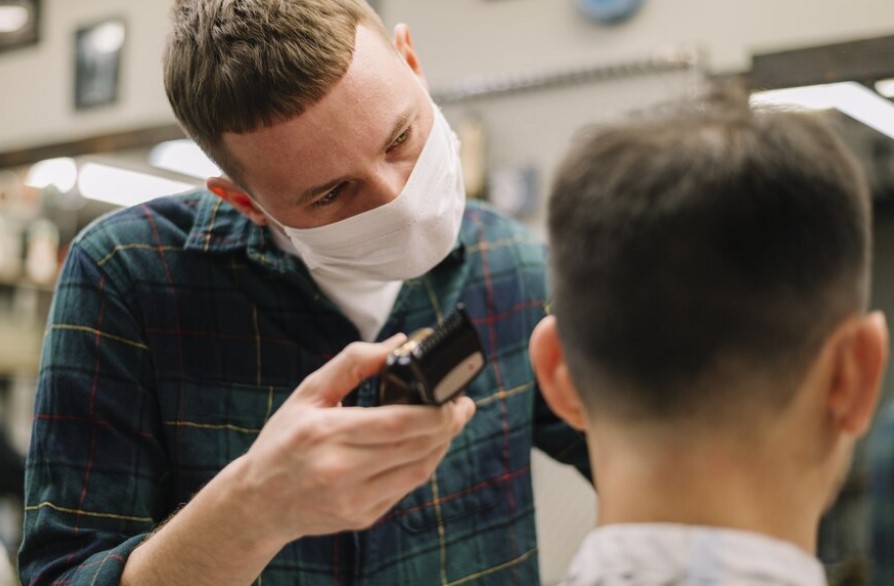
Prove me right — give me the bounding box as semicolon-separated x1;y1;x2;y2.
268;106;465;281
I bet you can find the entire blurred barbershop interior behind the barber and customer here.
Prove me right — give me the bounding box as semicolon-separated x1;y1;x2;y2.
0;0;894;585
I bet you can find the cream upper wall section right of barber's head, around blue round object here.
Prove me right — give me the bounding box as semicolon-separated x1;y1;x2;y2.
380;0;894;86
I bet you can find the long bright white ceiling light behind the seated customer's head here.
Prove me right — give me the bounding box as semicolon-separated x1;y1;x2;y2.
751;81;894;139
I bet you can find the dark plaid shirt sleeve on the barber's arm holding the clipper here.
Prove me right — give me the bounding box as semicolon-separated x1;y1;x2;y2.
19;242;173;586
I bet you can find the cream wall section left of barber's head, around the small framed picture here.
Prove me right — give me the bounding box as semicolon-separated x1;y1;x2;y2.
0;0;174;151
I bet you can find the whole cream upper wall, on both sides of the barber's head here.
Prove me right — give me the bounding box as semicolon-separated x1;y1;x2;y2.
0;0;894;151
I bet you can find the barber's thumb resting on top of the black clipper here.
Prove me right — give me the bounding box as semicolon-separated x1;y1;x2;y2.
289;334;407;407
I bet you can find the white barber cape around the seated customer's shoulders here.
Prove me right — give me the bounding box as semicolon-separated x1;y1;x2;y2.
562;523;827;586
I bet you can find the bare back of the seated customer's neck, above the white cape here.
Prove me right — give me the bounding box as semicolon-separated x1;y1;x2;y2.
589;424;826;553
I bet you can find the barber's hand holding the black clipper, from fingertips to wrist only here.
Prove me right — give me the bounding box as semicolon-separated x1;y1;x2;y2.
236;335;475;543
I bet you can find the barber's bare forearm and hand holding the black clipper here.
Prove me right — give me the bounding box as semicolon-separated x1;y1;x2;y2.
121;335;475;586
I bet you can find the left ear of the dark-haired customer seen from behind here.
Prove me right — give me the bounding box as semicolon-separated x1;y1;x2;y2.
528;315;587;431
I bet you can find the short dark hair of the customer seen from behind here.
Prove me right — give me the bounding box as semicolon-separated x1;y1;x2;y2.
548;91;871;418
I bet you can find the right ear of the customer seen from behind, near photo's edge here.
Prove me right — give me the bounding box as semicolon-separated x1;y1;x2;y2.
827;311;888;437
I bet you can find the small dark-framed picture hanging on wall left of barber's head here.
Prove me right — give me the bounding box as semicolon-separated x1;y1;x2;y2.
74;18;126;110
